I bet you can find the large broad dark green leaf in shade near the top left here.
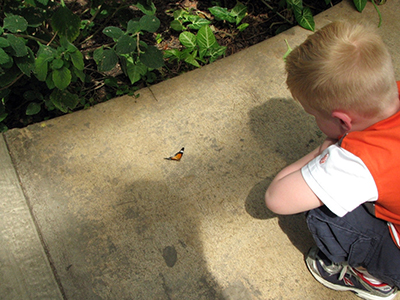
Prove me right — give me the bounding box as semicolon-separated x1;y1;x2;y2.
51;6;81;42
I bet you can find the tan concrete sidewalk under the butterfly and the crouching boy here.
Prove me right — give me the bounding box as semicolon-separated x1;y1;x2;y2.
0;0;400;300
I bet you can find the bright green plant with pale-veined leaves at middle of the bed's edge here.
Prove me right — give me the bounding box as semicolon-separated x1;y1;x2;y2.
164;25;226;67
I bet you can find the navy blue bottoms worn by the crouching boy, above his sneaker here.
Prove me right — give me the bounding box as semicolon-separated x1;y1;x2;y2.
306;205;400;287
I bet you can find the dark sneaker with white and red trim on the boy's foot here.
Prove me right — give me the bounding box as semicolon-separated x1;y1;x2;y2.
306;247;397;300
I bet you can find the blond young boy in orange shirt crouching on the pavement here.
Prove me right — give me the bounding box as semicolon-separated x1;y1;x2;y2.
266;22;400;299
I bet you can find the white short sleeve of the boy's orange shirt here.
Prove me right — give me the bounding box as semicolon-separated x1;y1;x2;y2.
301;145;378;217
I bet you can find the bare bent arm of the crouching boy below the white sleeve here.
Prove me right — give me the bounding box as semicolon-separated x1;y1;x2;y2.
265;139;336;215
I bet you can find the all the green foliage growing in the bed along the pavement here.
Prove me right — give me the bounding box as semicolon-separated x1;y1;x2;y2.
0;0;385;132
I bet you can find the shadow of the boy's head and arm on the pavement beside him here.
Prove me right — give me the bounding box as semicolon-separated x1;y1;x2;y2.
245;98;324;254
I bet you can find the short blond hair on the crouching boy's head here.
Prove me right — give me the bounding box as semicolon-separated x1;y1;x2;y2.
286;21;397;117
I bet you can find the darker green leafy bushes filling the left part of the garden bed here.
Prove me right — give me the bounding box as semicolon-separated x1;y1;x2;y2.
0;0;164;132
